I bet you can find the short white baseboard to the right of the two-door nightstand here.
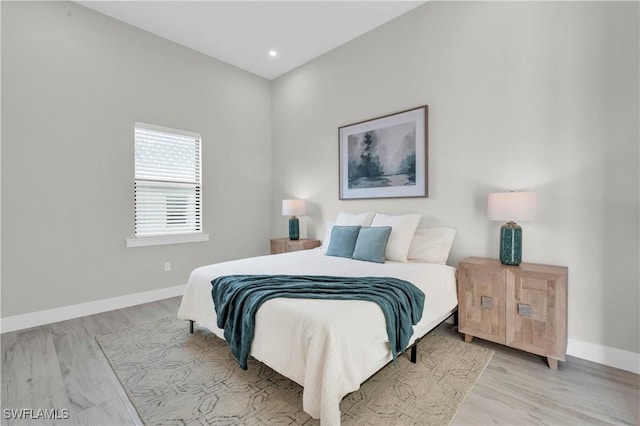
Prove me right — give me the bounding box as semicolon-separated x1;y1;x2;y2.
567;339;640;374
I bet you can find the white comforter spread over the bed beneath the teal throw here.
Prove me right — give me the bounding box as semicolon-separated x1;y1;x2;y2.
178;248;457;426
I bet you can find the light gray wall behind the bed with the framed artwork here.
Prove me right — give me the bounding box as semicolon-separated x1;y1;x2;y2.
272;2;640;353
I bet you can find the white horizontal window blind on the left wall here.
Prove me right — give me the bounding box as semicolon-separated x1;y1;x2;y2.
135;122;202;237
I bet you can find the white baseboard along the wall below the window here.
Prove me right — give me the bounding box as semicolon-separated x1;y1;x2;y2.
0;285;186;333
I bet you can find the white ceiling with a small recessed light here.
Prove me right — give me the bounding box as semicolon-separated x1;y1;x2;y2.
77;1;424;80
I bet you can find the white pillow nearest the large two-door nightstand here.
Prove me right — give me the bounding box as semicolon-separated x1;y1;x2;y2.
407;227;456;265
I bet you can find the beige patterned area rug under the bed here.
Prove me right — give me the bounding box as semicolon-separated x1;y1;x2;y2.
96;318;493;426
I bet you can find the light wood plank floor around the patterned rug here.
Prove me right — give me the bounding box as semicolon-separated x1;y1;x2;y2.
0;298;640;426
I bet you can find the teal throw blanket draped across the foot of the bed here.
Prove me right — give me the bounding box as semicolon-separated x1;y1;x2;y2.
211;275;424;370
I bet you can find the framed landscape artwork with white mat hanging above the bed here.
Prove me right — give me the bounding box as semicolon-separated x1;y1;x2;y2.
338;105;428;200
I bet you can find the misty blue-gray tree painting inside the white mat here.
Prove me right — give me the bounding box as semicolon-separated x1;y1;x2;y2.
347;122;416;189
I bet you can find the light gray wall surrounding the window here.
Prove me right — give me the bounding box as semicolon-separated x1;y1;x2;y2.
1;2;271;317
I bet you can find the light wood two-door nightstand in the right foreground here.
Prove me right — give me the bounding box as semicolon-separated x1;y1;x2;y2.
458;257;568;370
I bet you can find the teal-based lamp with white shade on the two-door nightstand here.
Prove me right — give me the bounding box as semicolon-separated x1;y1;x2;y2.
488;192;536;266
